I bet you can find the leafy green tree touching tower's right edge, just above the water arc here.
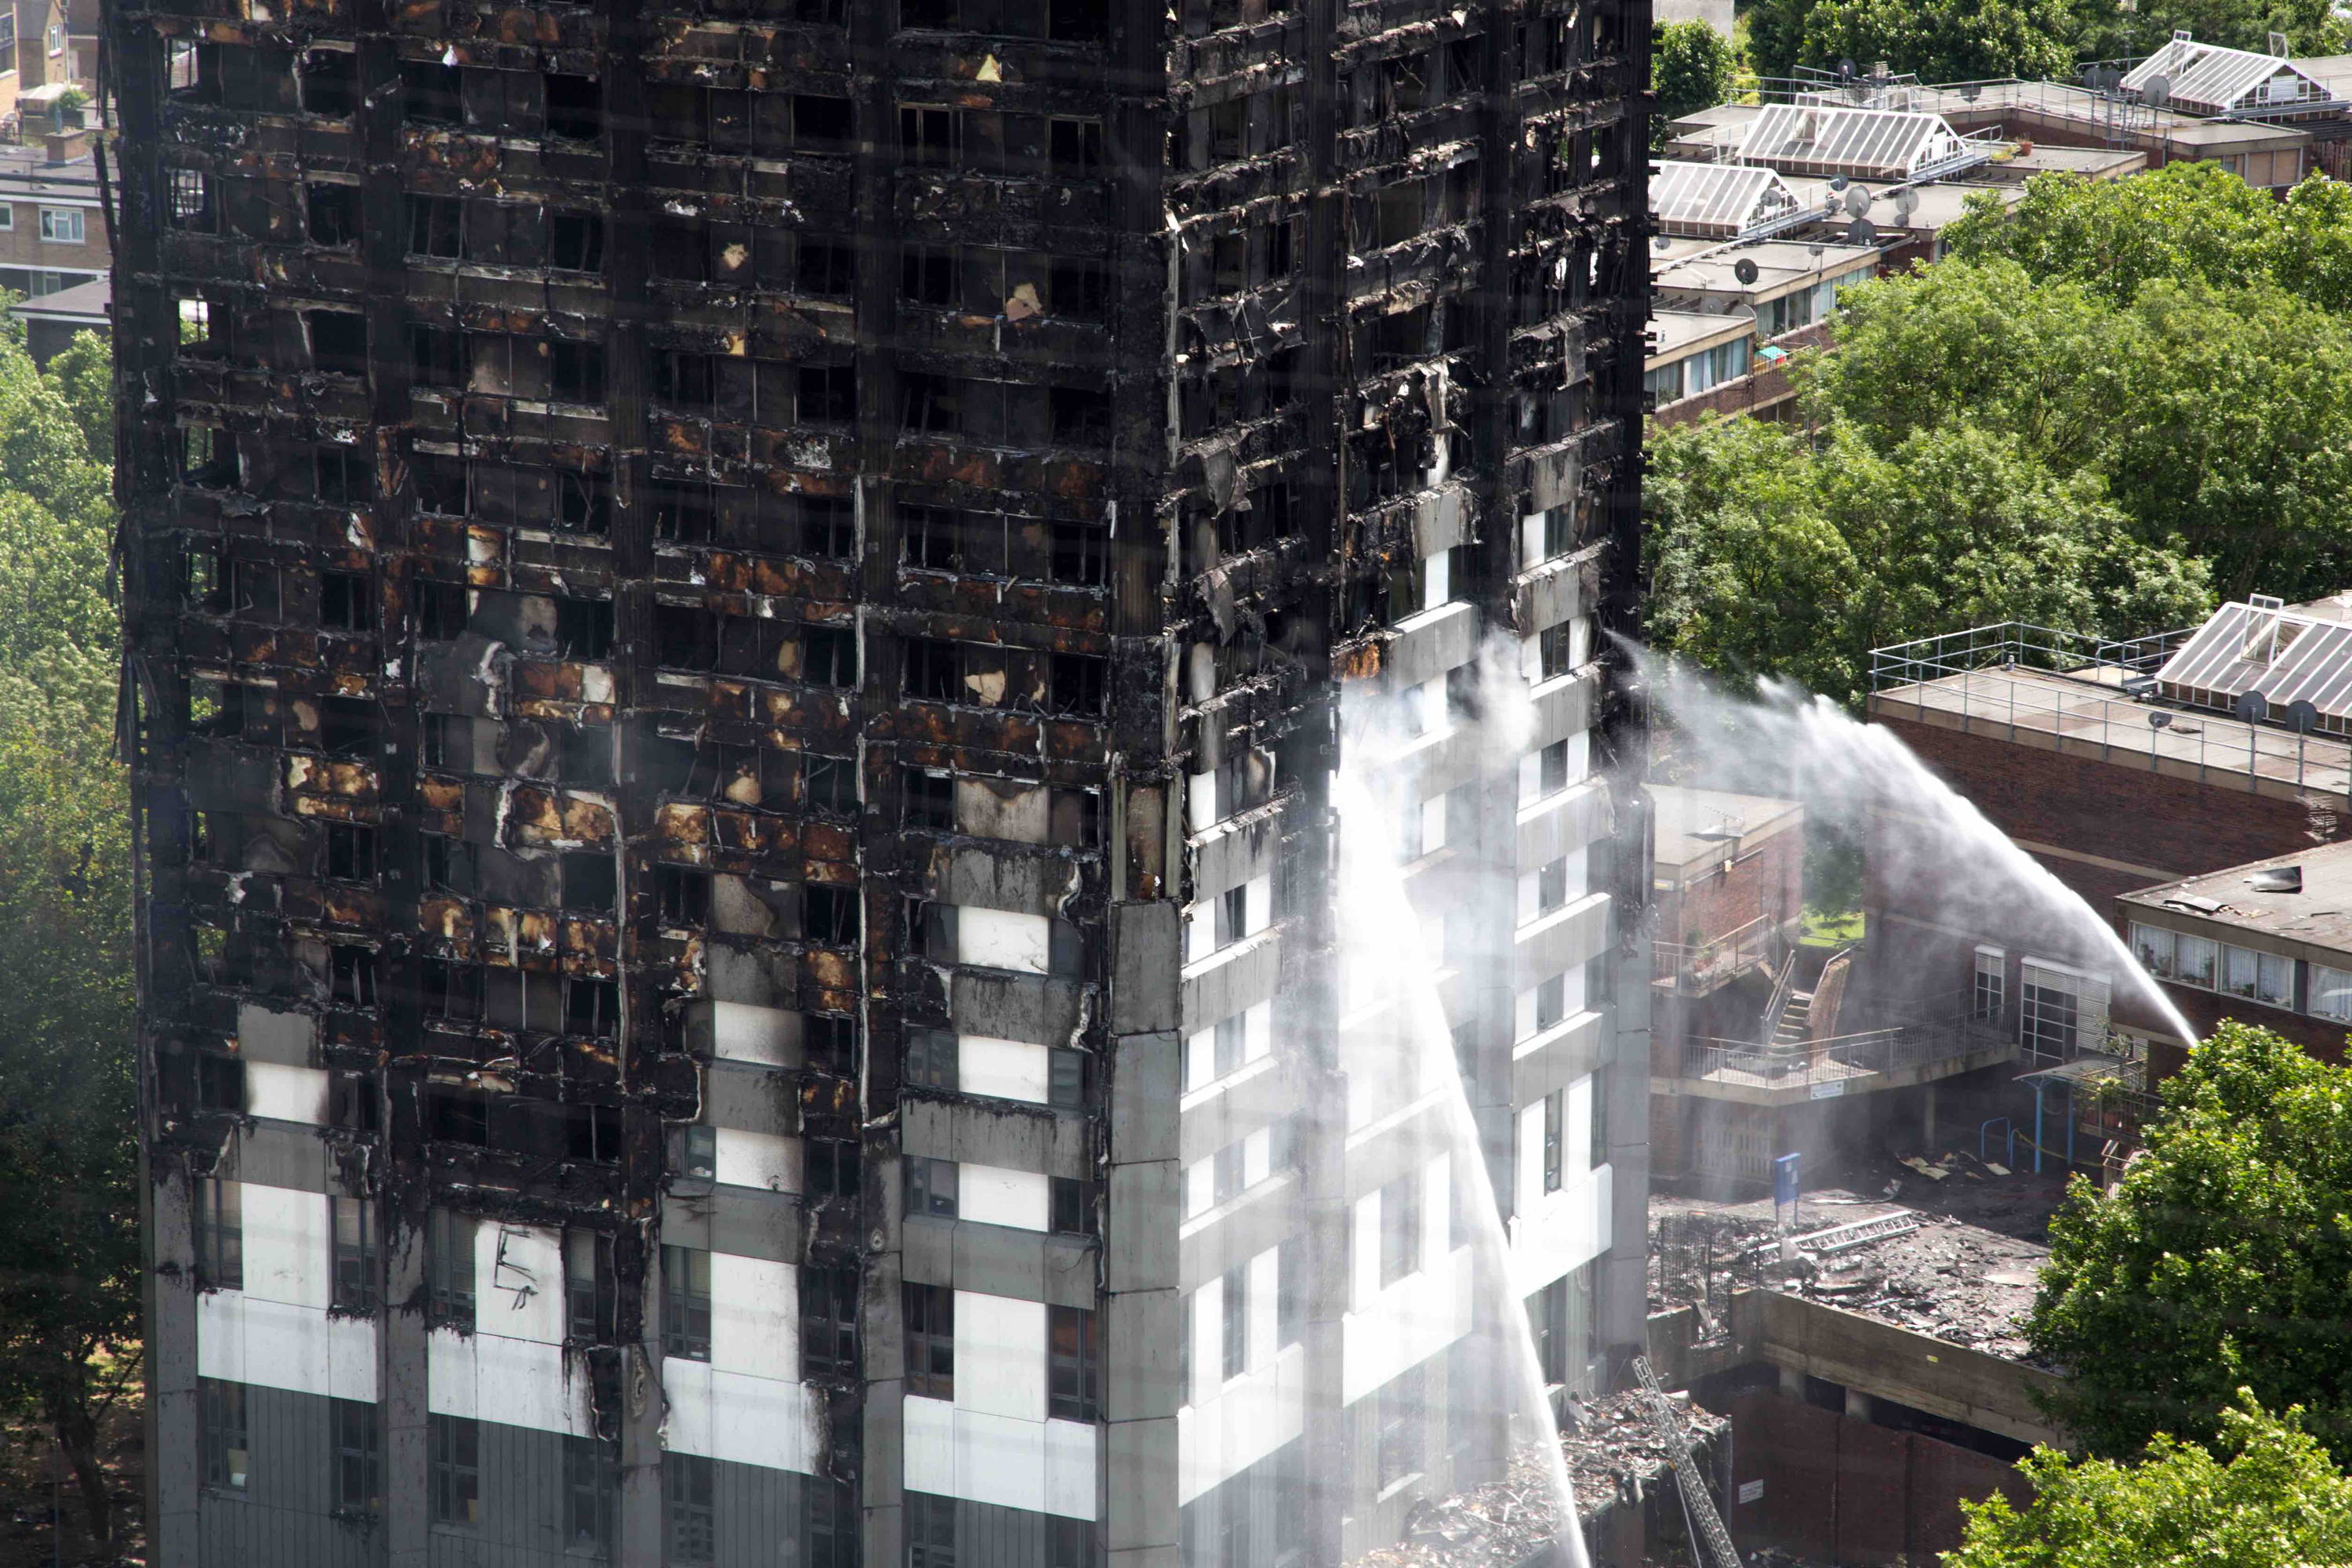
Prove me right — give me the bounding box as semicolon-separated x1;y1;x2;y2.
1646;404;2209;703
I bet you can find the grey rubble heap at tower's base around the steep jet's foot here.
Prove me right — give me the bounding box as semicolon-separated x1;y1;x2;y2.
1352;1389;1731;1568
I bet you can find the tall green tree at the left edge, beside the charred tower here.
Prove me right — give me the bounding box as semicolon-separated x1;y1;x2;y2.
0;321;139;1540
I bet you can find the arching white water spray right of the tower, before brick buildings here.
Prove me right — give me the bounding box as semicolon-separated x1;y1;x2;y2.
1623;642;2197;1044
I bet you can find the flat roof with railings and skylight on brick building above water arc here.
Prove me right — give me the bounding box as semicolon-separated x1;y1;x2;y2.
1870;666;2352;799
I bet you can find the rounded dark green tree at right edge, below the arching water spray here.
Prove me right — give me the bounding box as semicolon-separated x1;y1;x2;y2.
2025;1022;2352;1467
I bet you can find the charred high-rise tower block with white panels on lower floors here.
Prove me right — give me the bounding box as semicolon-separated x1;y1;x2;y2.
106;0;1649;1568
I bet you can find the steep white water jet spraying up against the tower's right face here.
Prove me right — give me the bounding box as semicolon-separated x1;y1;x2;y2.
1334;640;1590;1568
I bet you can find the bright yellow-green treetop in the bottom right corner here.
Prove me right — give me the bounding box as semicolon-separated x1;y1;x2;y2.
1943;1399;2352;1568
